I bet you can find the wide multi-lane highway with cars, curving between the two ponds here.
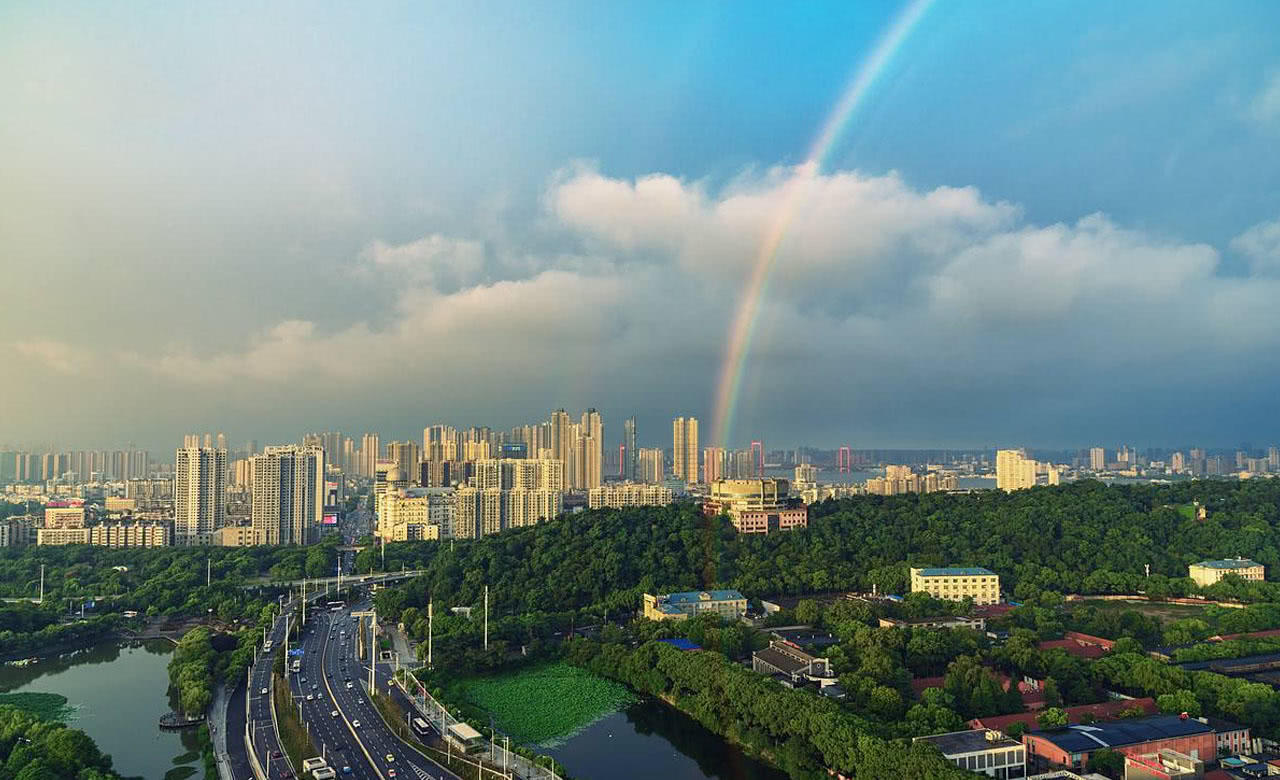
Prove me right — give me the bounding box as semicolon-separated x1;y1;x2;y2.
289;602;456;780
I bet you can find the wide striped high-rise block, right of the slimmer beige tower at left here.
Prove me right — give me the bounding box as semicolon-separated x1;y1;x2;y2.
251;437;325;544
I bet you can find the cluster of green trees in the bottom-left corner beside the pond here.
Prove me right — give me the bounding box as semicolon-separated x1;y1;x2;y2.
0;704;119;780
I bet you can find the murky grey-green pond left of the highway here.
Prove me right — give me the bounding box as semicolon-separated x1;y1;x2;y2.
0;639;204;780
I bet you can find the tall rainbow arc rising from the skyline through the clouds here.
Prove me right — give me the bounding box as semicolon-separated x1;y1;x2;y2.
713;0;933;447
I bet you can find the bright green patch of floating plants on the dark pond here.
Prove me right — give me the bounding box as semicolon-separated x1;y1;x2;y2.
458;663;632;745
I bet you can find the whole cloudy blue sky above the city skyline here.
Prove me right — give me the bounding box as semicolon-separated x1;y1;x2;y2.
0;0;1280;452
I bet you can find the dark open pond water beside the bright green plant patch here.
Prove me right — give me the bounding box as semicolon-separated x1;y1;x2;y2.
539;698;787;780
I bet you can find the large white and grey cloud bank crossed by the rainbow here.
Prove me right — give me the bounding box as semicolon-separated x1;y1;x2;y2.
35;167;1280;444
